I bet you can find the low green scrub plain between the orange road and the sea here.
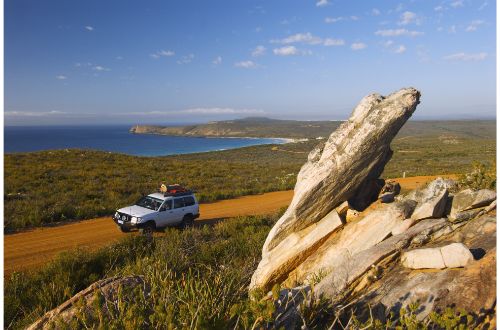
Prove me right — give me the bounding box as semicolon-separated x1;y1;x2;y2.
4;121;496;232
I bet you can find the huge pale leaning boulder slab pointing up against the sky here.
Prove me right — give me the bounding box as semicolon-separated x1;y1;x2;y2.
251;88;420;288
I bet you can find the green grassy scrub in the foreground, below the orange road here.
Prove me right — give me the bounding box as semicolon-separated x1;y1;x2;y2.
4;210;494;329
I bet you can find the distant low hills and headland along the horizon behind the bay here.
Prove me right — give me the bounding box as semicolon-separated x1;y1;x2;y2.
130;117;496;139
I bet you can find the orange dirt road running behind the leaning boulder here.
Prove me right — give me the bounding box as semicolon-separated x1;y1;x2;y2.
4;176;456;274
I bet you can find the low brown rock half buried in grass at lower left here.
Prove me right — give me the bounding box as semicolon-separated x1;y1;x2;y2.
27;275;146;330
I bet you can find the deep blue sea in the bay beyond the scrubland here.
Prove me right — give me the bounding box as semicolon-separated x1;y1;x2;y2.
4;126;285;156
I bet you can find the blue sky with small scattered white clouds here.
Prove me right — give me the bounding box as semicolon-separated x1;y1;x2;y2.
4;0;496;125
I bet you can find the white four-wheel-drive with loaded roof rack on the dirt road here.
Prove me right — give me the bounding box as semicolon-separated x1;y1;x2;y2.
113;190;200;235
